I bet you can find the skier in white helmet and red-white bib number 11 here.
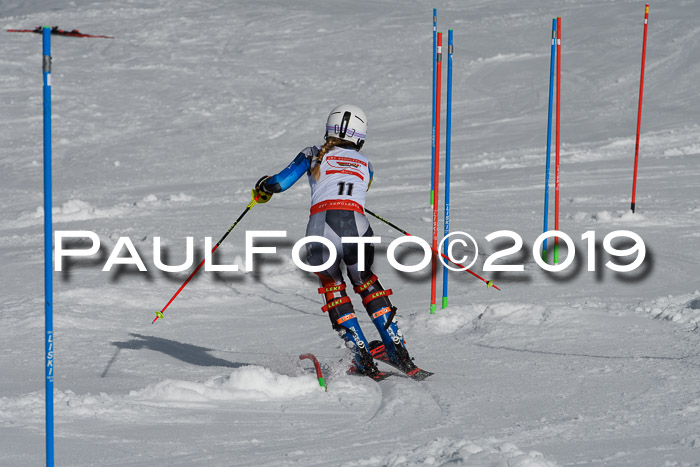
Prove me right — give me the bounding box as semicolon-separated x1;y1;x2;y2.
253;105;417;377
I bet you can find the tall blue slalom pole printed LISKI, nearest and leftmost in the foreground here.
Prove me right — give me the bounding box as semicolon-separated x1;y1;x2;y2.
42;26;54;467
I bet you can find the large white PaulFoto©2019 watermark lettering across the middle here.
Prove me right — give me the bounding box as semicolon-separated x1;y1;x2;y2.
54;230;646;273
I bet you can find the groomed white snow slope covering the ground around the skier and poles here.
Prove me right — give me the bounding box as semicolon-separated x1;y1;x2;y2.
0;0;700;467
